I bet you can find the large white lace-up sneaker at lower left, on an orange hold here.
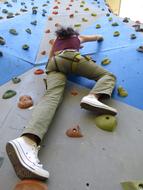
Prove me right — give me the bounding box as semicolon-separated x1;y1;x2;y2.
6;136;49;180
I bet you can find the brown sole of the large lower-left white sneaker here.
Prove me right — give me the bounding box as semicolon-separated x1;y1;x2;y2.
6;142;47;181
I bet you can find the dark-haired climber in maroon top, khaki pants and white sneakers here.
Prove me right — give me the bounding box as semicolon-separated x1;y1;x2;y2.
6;27;117;180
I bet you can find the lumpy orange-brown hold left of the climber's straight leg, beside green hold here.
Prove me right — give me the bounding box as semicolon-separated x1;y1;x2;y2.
17;95;33;109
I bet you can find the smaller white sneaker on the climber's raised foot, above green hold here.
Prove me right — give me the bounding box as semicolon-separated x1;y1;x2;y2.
80;94;117;115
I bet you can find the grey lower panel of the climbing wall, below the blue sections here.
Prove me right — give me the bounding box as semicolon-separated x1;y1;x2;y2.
0;70;143;190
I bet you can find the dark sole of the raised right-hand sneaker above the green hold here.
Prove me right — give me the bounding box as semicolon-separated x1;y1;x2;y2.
80;102;117;115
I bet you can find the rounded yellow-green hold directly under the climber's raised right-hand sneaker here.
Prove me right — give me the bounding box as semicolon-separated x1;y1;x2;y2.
95;115;117;131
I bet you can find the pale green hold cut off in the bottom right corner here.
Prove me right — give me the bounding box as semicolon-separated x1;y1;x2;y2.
121;181;143;190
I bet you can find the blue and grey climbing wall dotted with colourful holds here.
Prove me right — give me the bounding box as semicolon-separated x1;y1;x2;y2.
0;0;143;190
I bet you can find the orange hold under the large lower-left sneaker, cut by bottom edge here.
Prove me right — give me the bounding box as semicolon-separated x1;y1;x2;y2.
14;179;48;190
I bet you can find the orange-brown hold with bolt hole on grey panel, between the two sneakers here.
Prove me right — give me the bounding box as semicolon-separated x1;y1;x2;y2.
66;125;83;137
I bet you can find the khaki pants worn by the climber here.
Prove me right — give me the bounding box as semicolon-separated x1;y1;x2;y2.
23;50;116;140
